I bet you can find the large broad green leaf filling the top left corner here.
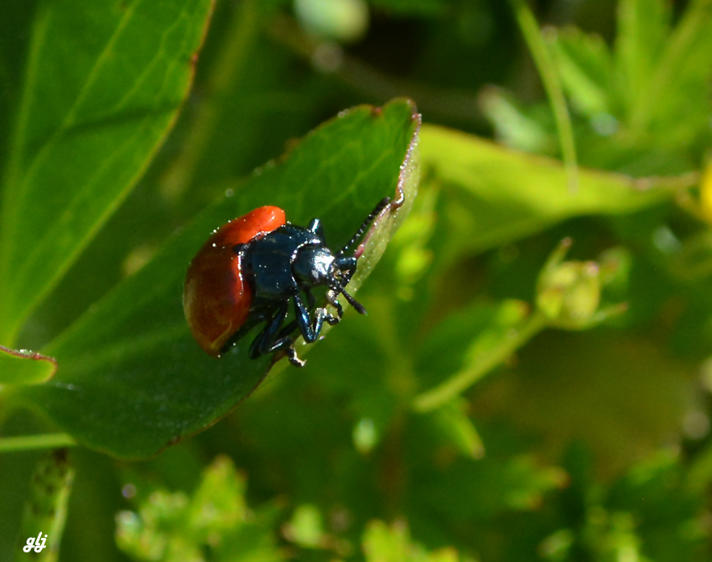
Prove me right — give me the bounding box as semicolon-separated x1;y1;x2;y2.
0;0;211;343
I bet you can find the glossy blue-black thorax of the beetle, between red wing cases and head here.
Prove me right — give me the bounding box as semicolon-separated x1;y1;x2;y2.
236;224;330;305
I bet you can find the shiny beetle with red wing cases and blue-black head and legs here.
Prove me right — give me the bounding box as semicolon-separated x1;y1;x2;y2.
183;197;390;367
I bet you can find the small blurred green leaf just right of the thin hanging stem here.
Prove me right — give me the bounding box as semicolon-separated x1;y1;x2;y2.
546;28;613;116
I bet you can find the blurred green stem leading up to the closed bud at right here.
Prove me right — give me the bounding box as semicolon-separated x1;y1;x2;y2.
413;312;547;413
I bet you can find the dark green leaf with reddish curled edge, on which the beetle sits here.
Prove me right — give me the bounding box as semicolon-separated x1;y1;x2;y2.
11;100;420;457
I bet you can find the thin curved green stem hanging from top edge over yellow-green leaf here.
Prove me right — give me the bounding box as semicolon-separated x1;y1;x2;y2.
510;0;578;192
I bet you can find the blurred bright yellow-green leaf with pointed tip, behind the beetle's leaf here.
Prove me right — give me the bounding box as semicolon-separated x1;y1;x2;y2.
422;125;698;262
